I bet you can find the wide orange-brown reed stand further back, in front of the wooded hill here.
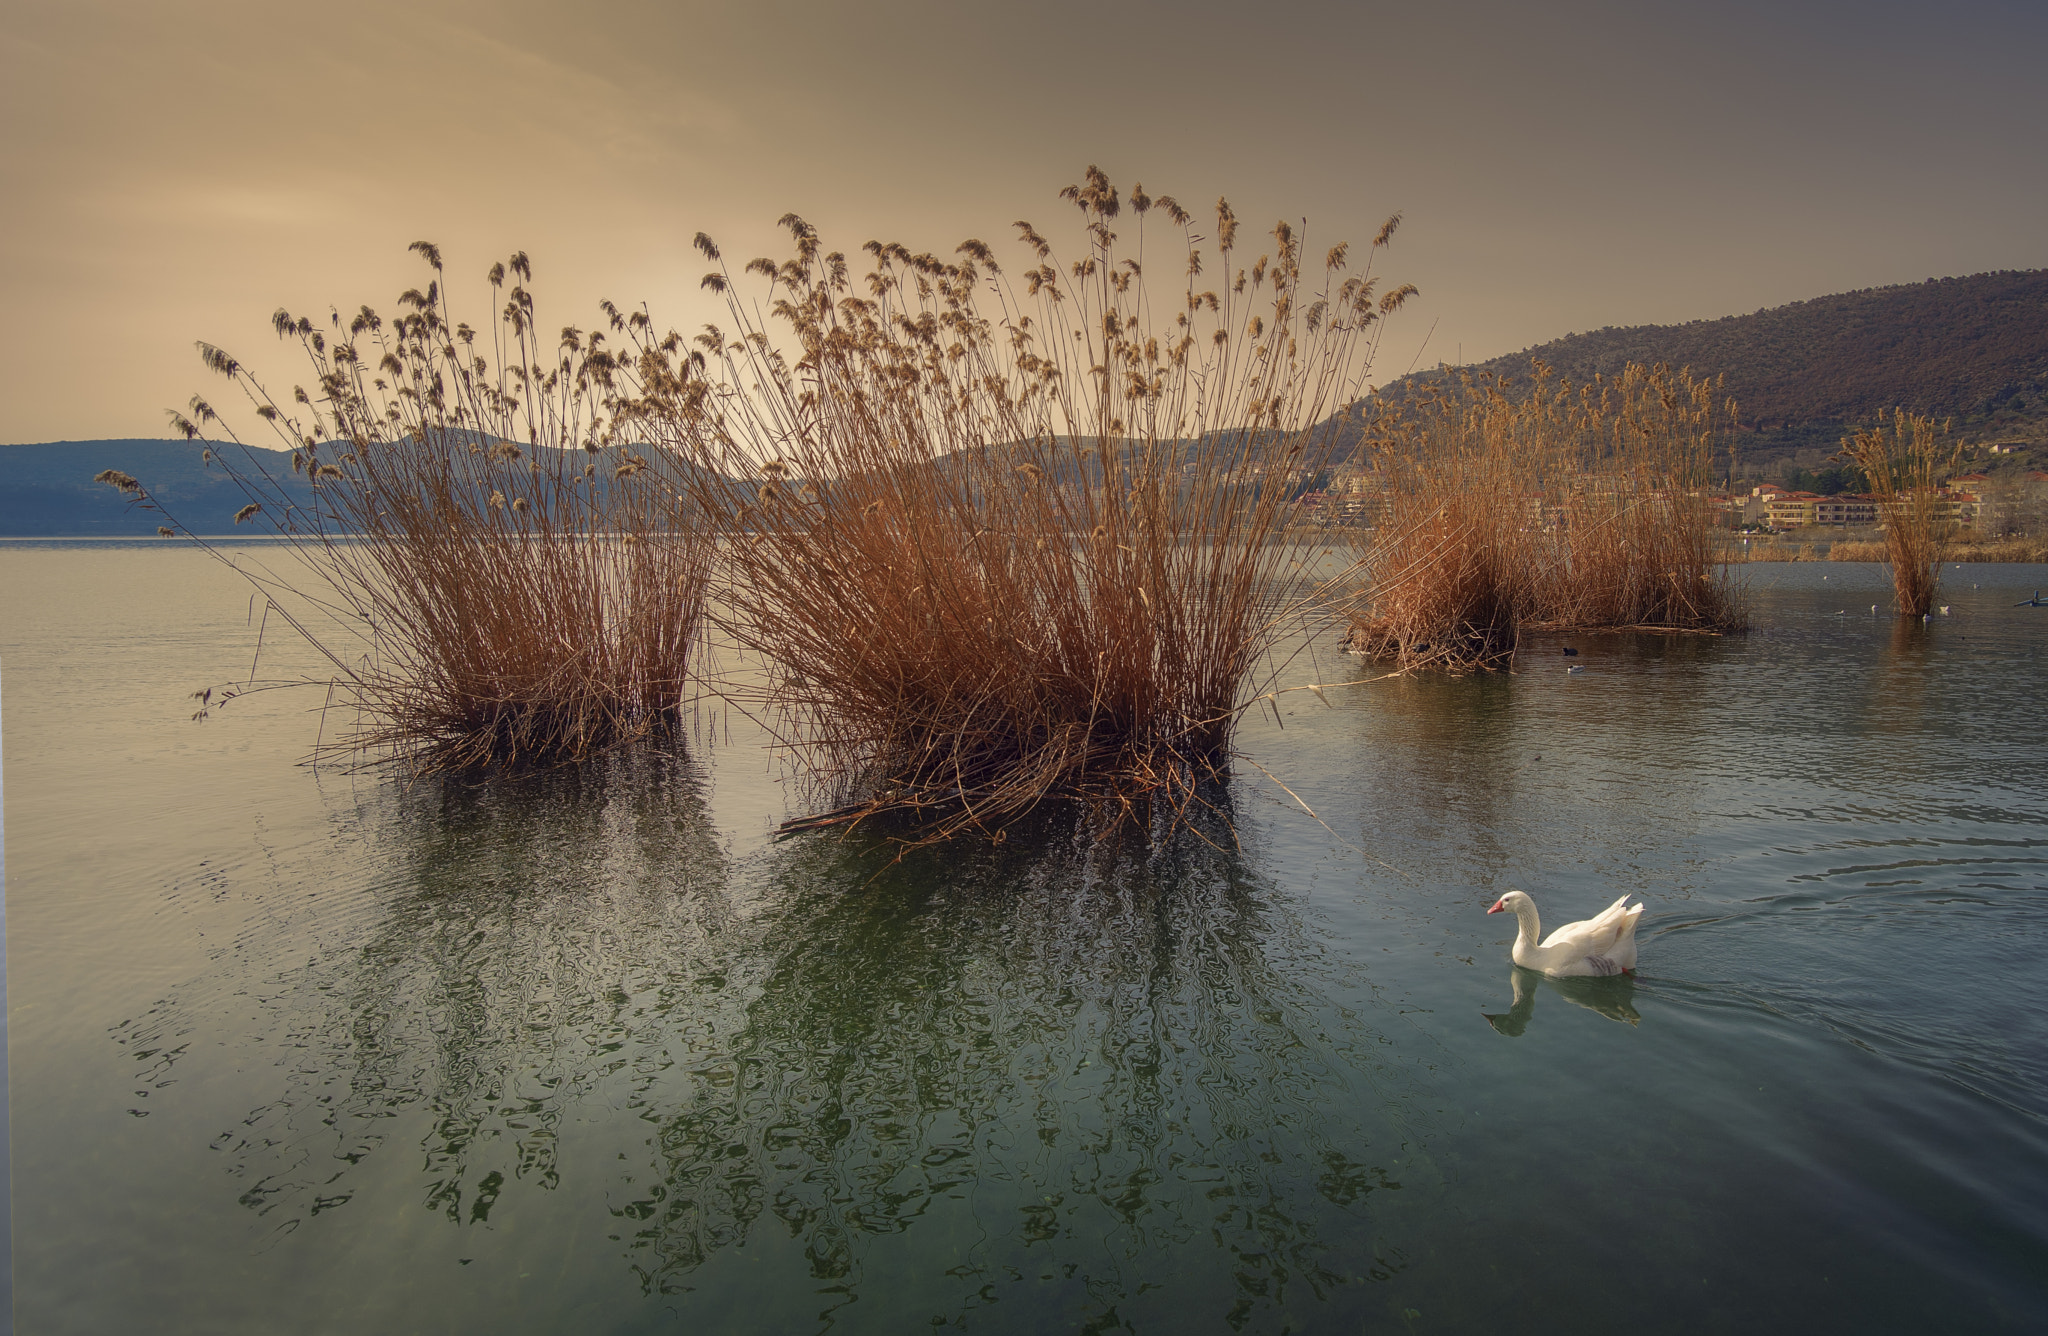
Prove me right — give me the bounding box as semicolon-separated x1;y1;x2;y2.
1350;365;1743;670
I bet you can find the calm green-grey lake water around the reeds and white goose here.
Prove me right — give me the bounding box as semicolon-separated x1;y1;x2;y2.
0;543;2048;1334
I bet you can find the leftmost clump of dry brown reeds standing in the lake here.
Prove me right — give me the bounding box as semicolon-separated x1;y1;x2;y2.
136;242;711;773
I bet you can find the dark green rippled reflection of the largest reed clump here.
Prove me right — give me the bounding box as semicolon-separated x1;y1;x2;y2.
623;803;1441;1324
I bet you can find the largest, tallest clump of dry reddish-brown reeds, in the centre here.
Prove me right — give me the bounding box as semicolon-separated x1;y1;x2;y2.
622;168;1413;844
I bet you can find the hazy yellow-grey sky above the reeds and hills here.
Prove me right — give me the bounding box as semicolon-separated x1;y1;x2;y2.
0;0;2048;443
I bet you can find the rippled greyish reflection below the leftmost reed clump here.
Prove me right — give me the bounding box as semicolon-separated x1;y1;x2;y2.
213;754;737;1231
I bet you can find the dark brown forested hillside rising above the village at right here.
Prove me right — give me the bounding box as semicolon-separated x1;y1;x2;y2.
1400;268;2048;461
